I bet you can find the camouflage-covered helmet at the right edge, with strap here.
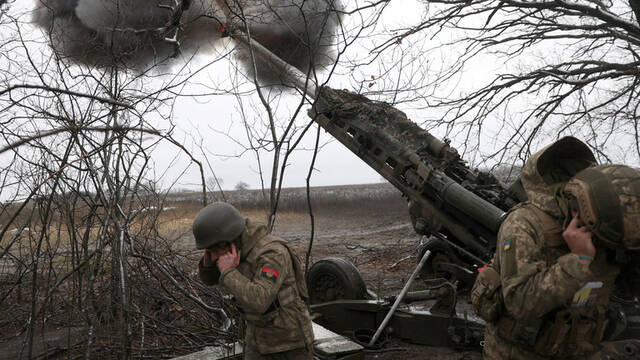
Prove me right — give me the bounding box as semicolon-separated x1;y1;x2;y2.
564;165;640;250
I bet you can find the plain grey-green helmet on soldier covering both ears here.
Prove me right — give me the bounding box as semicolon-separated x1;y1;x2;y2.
193;202;245;249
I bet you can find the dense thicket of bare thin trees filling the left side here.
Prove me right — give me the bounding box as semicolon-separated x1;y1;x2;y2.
0;2;237;358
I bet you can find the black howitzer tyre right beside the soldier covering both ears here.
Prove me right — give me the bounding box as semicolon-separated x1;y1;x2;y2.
307;257;367;304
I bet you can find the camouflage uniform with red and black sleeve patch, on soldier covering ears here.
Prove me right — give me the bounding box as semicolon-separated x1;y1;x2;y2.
198;219;313;359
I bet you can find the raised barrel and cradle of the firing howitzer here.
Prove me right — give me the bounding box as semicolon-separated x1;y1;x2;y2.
234;31;522;278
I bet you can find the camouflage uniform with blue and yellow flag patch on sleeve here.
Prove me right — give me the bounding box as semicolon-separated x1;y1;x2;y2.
472;137;640;359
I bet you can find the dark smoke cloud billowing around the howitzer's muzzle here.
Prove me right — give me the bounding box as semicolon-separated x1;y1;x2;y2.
34;0;341;83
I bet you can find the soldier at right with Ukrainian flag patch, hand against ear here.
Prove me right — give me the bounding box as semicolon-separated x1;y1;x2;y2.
472;137;640;359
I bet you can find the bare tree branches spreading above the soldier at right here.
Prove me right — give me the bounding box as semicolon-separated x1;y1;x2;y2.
364;0;640;164
